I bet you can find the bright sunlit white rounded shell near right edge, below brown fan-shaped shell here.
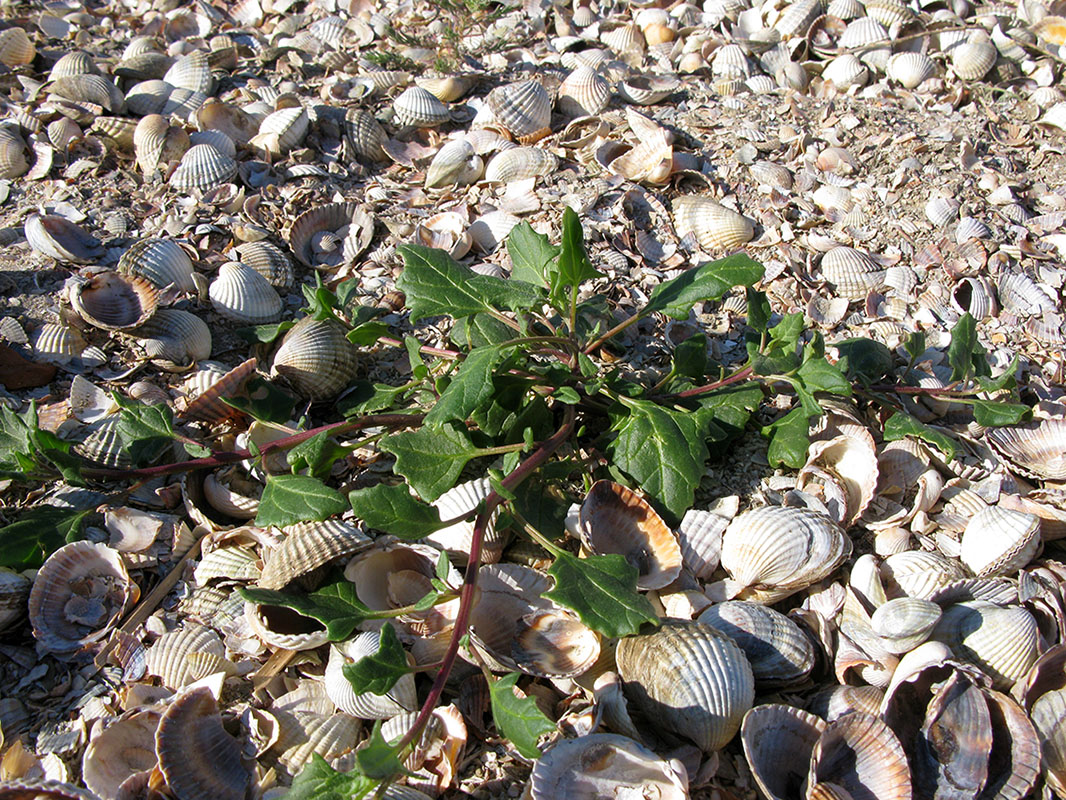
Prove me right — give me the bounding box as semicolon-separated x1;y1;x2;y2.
959;506;1041;578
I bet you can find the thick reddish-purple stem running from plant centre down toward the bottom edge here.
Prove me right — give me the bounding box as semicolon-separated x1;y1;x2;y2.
397;405;576;752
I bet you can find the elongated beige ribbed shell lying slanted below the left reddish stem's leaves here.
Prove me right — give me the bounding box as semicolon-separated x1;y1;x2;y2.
257;519;373;589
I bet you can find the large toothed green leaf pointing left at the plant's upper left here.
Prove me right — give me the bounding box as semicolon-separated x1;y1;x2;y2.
397;244;543;322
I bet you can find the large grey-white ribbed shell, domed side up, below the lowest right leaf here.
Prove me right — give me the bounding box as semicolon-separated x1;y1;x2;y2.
615;620;755;753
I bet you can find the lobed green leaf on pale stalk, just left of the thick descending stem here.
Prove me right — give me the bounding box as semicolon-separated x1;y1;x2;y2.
378;422;478;502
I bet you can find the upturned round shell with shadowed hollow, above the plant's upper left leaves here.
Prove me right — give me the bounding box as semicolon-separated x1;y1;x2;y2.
289;203;374;270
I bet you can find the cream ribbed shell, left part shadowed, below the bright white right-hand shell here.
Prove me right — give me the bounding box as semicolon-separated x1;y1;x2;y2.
932;601;1040;691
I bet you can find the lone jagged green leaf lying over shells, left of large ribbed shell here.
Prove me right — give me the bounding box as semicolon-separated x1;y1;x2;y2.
544;550;659;639
